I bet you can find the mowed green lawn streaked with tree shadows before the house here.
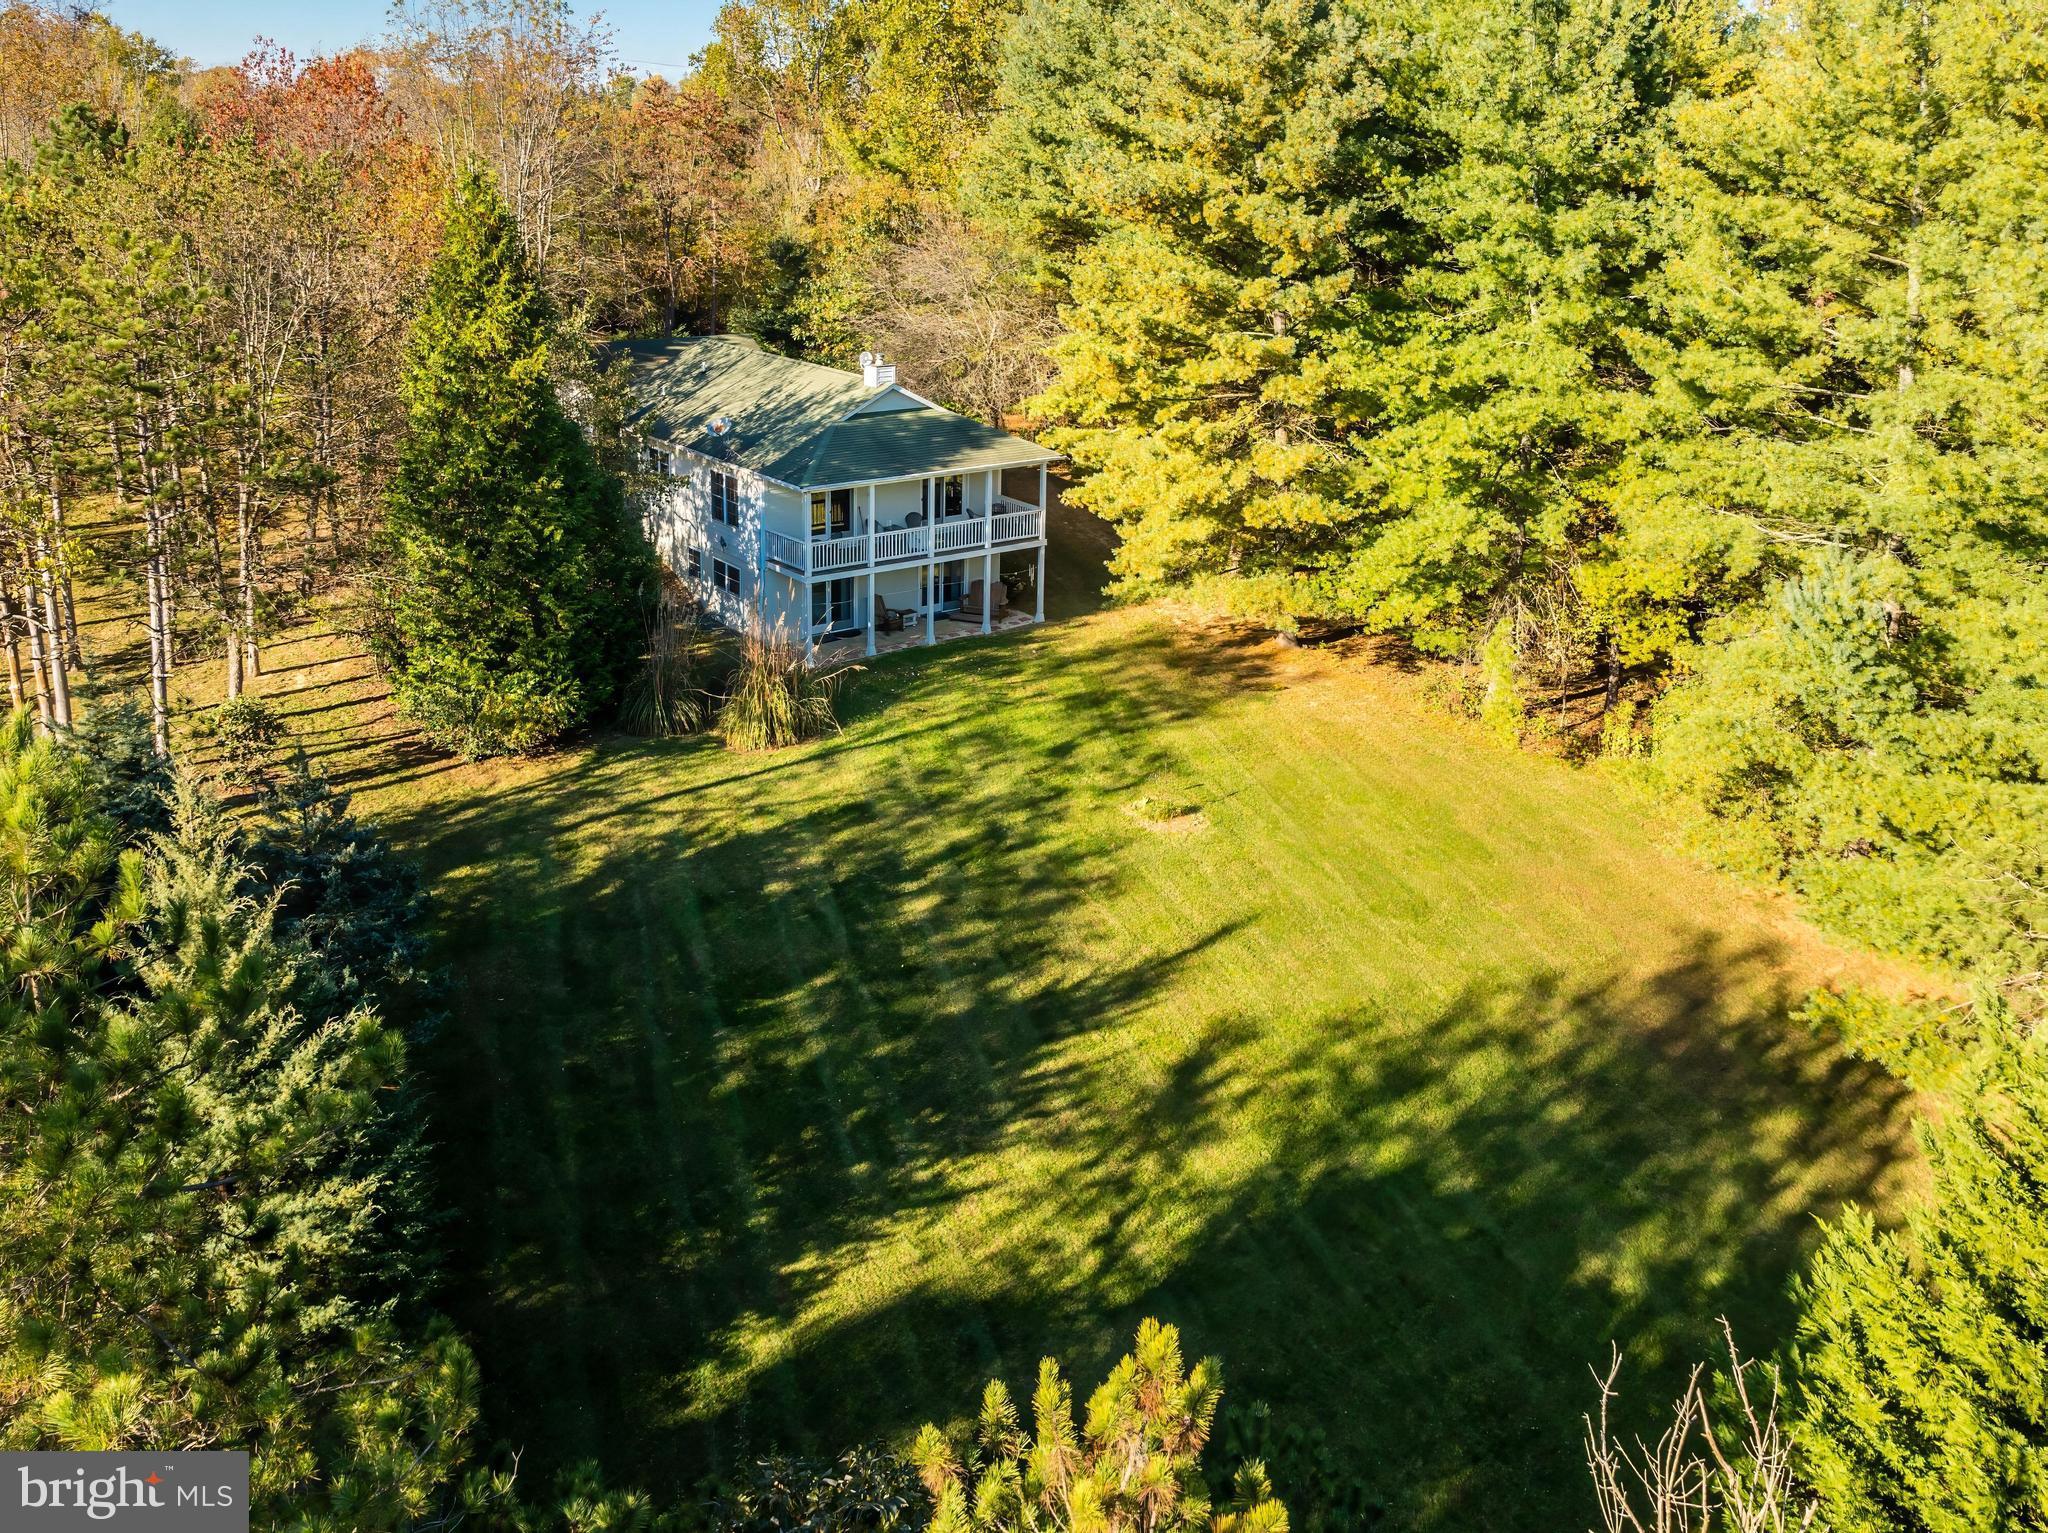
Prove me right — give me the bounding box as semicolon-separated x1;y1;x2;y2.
64;499;1911;1529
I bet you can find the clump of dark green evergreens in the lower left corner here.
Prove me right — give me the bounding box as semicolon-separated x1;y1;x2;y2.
0;712;487;1533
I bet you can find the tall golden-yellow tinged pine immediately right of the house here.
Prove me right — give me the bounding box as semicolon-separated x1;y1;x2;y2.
983;0;1415;610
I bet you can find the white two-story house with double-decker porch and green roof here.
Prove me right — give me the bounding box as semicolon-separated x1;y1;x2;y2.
612;336;1059;657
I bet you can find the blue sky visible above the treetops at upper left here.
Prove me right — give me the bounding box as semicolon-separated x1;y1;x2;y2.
96;0;719;74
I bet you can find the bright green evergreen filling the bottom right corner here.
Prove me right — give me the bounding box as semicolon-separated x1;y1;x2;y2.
1796;1038;2048;1533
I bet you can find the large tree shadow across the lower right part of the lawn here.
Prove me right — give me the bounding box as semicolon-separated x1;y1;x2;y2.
666;949;1905;1529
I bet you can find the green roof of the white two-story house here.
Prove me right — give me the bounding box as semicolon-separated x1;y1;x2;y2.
608;336;1059;489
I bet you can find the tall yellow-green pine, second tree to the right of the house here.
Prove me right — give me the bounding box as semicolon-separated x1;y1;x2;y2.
1351;0;1704;669
